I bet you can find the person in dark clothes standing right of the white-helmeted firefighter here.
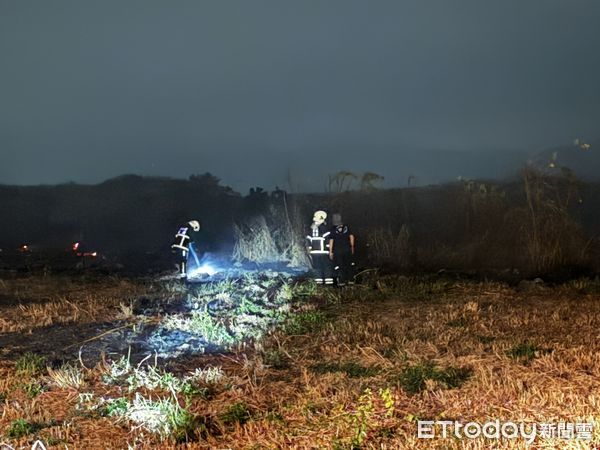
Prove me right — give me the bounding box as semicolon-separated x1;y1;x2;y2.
329;214;355;286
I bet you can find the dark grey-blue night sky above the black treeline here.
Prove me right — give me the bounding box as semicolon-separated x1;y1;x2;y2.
0;0;600;191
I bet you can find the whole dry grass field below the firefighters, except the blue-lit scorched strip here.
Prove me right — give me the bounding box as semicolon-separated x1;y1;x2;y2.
0;275;600;449
